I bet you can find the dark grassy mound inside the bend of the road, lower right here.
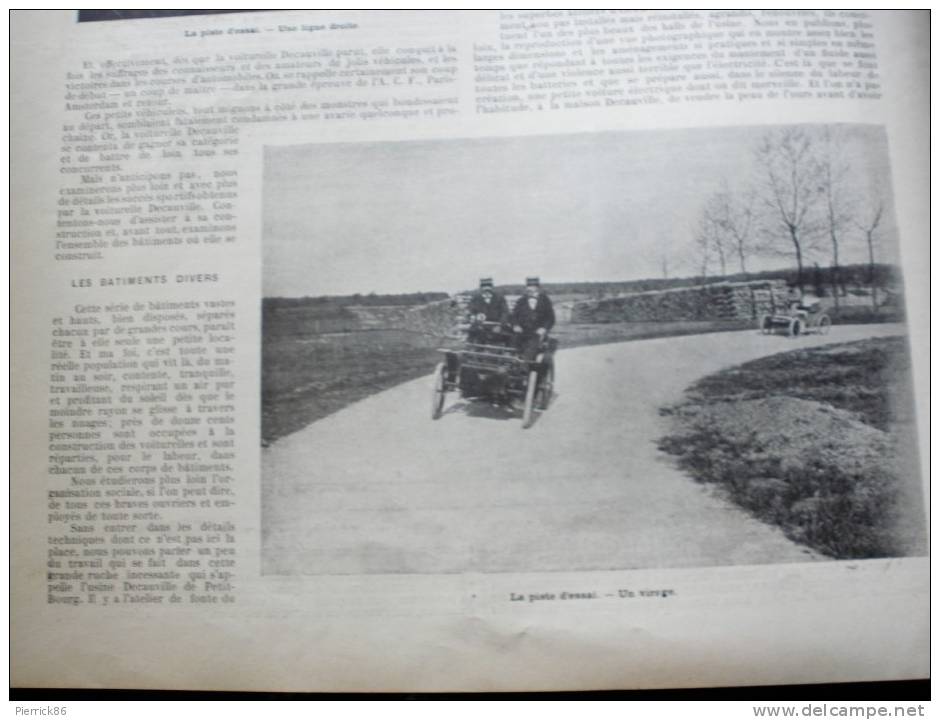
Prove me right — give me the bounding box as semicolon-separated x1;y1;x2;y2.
660;337;925;558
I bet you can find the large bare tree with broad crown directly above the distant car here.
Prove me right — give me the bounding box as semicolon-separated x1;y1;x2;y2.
755;127;820;291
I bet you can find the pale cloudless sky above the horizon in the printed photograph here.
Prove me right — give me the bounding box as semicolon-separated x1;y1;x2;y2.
262;125;896;297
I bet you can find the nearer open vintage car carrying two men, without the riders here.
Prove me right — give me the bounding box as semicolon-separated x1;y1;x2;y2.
431;322;558;428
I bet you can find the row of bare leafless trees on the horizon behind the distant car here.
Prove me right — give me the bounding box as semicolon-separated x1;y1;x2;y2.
693;126;885;306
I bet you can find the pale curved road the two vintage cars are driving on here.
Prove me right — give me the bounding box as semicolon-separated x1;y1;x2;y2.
262;325;904;574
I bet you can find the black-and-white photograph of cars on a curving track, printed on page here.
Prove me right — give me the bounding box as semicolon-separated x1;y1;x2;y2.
261;124;926;575
